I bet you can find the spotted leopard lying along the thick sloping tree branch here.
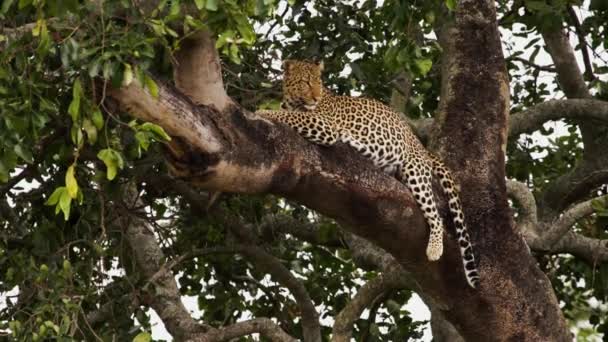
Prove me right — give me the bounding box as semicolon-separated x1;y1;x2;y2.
256;59;480;288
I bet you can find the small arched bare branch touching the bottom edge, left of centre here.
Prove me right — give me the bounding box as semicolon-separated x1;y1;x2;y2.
188;318;298;342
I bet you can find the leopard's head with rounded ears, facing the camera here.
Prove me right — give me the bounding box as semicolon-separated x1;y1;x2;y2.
282;59;323;111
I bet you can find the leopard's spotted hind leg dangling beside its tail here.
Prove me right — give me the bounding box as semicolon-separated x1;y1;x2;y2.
400;161;443;261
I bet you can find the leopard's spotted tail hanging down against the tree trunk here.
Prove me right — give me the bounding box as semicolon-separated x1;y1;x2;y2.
431;156;479;288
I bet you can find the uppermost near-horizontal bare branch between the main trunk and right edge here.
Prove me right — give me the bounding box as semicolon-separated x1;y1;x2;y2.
509;99;608;137
